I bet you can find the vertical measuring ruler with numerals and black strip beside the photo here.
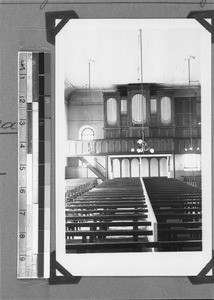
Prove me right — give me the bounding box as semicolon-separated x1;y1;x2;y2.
17;52;51;278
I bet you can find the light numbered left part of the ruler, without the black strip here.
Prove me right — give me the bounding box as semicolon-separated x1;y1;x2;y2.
17;52;38;278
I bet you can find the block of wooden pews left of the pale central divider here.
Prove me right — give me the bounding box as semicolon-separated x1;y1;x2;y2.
65;178;153;253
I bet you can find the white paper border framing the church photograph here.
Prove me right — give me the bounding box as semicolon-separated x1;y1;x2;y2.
55;19;212;276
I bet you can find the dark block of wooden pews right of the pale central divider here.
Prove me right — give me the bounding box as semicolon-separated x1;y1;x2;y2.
144;178;202;251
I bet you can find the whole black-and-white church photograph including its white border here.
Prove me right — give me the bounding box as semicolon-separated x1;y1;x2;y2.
56;19;211;275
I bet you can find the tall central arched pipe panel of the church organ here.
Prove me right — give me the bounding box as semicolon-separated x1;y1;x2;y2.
131;94;146;125
